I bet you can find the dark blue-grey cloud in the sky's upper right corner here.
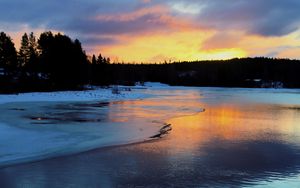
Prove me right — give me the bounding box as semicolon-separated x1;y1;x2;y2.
168;0;300;36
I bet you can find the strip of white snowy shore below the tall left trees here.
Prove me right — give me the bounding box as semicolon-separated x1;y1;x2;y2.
0;82;170;104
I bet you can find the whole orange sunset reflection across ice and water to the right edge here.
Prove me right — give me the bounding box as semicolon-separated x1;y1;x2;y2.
108;95;300;154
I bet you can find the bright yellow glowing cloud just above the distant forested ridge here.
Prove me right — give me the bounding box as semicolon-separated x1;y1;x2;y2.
95;30;246;63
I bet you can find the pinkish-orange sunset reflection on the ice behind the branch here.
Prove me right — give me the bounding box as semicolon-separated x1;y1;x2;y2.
108;92;202;124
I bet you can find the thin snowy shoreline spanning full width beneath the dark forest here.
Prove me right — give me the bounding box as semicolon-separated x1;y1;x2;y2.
0;82;300;104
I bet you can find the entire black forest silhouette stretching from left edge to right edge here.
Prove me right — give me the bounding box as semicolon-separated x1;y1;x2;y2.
0;32;300;92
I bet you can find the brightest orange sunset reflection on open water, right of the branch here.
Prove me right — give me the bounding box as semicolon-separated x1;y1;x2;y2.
170;106;243;141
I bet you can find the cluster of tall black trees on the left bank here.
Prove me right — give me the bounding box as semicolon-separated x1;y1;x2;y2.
0;32;96;92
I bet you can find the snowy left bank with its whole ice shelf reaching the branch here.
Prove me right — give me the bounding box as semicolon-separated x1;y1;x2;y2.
0;83;201;166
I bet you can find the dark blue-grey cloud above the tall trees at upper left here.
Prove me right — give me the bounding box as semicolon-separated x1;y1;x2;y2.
0;0;152;45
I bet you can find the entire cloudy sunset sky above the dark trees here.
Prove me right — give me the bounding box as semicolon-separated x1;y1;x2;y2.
0;0;300;63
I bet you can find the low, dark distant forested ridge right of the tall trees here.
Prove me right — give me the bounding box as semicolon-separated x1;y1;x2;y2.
104;57;300;88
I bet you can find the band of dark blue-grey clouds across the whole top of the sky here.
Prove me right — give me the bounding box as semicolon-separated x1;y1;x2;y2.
0;0;300;48
